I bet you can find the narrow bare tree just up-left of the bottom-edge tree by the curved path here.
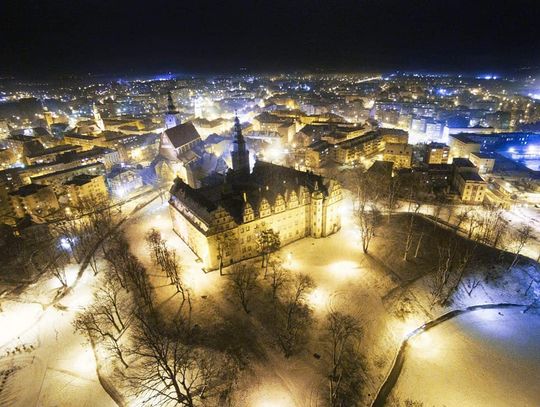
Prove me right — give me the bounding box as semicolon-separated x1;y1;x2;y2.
277;274;315;358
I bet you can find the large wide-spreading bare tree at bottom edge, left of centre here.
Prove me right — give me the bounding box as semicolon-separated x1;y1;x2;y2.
125;313;235;407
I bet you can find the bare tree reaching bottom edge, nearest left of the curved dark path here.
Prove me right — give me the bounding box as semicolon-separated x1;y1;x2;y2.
324;311;362;407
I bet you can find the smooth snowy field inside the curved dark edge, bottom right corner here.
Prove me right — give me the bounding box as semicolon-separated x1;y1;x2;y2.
393;309;540;407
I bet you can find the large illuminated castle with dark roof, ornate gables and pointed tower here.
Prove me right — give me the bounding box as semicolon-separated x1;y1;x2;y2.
169;118;341;270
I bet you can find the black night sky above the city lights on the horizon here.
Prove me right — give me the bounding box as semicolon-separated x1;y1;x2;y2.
0;0;540;77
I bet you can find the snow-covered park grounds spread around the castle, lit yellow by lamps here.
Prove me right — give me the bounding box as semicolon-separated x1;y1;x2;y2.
0;189;540;407
